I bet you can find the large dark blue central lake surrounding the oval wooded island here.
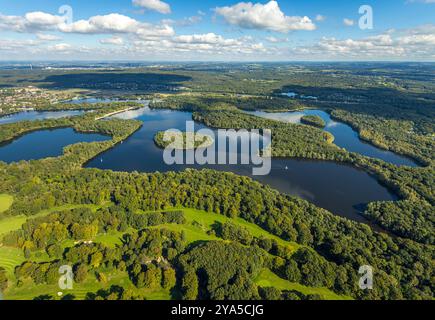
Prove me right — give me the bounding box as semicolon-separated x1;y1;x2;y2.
86;108;397;222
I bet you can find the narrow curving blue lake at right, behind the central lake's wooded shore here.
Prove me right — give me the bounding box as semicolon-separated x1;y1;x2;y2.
249;110;419;167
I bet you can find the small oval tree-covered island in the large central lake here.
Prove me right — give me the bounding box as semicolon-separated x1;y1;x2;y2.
154;131;214;150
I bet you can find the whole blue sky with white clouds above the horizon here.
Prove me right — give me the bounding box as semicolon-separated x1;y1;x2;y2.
0;0;435;61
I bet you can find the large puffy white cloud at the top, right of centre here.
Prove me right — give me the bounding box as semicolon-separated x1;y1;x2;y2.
215;1;316;33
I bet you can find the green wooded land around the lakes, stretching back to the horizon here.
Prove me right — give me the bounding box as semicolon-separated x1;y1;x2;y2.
0;65;435;300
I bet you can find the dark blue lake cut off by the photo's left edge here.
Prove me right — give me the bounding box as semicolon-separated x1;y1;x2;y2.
0;128;110;163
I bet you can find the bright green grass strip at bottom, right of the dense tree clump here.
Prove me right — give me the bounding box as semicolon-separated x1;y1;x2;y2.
255;269;352;300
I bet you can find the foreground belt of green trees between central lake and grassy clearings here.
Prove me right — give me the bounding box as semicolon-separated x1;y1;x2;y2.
2;169;433;299
